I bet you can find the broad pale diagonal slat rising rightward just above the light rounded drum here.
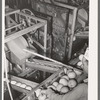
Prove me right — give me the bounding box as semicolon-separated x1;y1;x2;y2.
5;23;45;43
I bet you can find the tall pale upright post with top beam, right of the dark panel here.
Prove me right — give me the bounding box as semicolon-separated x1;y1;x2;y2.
51;0;88;60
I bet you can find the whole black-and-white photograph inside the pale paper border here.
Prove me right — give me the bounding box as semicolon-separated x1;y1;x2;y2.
2;0;91;100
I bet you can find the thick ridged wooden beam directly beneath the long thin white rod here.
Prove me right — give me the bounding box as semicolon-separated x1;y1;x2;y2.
26;59;61;73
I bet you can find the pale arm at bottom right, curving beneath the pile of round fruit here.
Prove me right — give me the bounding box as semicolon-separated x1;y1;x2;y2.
48;84;88;100
